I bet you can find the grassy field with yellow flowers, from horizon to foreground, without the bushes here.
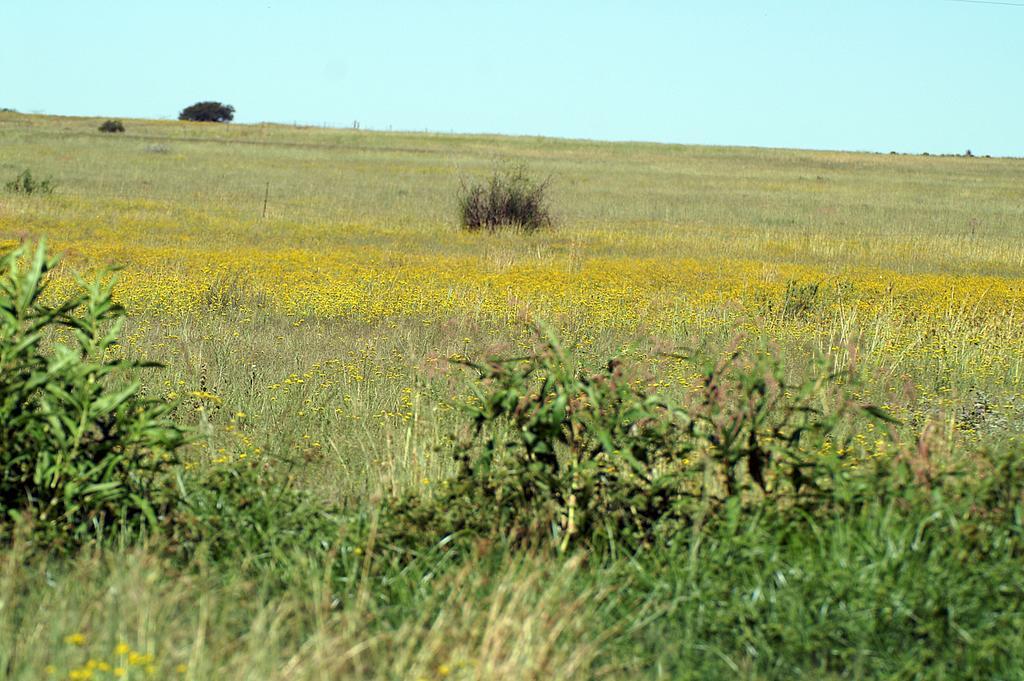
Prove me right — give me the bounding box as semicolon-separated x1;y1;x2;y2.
0;113;1024;679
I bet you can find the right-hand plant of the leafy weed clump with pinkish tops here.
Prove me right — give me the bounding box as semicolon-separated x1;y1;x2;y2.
680;337;895;501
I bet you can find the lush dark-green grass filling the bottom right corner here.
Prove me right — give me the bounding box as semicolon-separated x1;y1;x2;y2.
605;497;1024;679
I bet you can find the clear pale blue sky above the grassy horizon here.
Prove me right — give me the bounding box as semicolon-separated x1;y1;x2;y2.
0;0;1024;156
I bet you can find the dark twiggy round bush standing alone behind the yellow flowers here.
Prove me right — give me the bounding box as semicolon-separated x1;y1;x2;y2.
459;167;552;231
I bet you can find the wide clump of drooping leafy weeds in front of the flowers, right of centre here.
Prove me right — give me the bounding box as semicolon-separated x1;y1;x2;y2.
387;329;886;551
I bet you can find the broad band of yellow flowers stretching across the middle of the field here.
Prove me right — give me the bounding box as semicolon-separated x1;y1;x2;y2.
8;214;1024;399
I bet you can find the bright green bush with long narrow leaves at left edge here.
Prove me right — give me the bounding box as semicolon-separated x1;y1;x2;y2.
0;243;185;542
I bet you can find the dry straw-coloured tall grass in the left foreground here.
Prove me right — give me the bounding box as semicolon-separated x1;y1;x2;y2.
0;549;609;680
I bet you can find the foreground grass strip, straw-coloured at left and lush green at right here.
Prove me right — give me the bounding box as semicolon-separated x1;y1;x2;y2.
8;497;1024;679
